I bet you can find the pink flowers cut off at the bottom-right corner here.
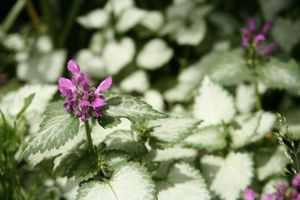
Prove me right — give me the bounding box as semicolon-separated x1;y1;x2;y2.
243;174;300;200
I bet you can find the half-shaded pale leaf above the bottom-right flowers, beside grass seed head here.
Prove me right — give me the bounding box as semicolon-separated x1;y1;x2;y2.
255;145;290;181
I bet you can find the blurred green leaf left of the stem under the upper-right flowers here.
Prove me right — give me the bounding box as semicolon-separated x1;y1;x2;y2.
206;49;251;85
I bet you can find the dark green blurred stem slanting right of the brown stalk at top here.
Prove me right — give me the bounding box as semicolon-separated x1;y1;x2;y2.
58;0;83;47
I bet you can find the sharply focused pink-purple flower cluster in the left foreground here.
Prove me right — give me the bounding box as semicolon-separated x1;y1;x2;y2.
58;60;112;121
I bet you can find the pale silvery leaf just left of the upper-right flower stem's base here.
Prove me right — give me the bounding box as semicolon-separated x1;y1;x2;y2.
230;111;262;148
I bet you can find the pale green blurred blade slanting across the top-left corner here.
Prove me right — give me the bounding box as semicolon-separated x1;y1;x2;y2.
2;0;25;32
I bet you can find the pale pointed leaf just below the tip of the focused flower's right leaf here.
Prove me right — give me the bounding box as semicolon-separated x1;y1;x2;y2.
148;118;201;149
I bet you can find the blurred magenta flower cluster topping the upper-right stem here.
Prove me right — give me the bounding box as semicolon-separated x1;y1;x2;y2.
240;17;276;56
